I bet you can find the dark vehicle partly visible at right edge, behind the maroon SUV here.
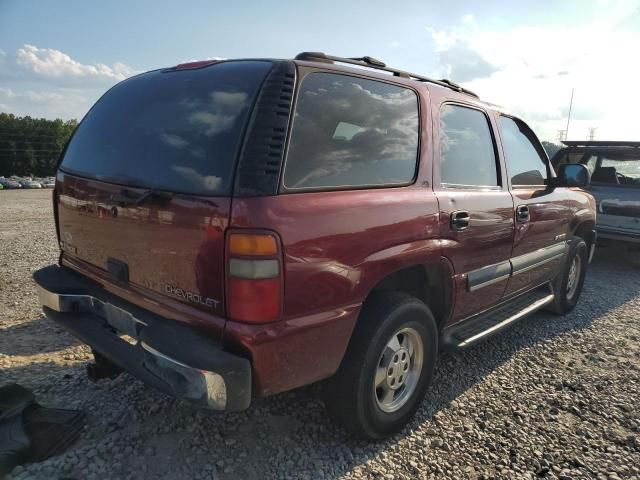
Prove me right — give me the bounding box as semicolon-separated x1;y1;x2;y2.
551;140;640;246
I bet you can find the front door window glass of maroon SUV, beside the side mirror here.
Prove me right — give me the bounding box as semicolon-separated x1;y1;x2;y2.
500;116;547;185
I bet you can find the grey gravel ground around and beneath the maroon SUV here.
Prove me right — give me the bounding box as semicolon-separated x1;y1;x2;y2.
0;191;640;480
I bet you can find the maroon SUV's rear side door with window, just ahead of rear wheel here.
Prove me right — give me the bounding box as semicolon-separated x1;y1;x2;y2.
434;103;514;322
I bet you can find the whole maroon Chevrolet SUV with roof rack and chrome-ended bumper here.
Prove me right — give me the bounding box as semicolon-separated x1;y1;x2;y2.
34;53;596;439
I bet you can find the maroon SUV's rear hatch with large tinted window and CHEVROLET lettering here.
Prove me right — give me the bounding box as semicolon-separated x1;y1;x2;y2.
56;61;272;322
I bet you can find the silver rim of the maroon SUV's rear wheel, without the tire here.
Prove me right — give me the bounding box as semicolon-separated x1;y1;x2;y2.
373;328;424;413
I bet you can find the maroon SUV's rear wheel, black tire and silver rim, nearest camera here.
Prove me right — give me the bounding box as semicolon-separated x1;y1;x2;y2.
324;292;438;440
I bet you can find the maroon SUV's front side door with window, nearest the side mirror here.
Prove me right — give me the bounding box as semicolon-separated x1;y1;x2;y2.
498;115;572;295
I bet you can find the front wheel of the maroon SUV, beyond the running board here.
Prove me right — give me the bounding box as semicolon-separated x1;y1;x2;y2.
548;237;589;315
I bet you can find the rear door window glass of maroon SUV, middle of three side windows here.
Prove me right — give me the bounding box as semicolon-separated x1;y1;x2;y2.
440;104;498;187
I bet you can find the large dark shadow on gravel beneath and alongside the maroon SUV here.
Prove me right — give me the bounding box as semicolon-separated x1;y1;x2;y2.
6;249;640;480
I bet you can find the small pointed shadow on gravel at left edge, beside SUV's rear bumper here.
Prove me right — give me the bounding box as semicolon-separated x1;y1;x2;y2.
0;317;80;356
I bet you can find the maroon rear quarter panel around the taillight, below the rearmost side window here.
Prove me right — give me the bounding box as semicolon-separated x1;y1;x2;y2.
225;187;441;395
